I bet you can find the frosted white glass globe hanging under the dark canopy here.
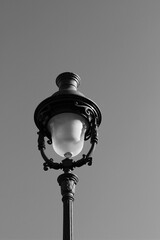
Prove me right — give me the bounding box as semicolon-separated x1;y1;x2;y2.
48;113;87;158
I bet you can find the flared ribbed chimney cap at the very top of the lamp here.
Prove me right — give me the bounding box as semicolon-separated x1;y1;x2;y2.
56;72;81;91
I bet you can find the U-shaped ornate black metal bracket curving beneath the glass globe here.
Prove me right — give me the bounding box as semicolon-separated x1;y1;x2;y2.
38;119;98;172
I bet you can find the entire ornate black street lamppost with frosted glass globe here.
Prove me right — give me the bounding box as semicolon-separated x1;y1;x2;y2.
34;72;102;240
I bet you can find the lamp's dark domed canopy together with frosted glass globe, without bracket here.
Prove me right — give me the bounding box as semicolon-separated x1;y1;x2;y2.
34;72;101;158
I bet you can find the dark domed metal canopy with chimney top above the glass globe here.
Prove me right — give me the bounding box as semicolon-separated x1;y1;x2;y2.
34;72;102;142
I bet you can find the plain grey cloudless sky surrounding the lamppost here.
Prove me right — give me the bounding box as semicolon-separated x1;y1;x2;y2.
0;0;160;240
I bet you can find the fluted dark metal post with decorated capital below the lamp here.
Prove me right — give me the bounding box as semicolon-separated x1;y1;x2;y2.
57;173;78;240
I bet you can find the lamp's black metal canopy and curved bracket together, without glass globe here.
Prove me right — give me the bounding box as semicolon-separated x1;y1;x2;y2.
34;72;102;173
